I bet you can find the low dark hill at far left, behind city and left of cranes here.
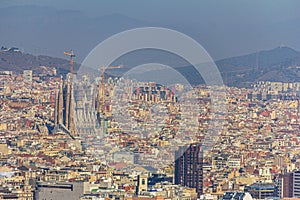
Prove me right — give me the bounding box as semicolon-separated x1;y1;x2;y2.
0;51;79;74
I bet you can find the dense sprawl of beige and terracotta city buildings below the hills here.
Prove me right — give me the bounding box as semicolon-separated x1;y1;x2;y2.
0;57;300;199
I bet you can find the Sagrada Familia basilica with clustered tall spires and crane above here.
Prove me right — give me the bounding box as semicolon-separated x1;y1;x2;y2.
54;51;103;139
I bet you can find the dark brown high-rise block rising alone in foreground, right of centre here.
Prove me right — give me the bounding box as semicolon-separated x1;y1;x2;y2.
174;143;203;197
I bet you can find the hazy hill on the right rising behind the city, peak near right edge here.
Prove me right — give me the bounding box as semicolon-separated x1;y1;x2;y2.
178;47;300;87
